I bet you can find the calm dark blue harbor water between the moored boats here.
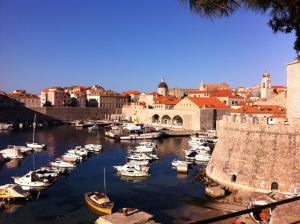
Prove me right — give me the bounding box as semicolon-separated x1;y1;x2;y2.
0;126;204;224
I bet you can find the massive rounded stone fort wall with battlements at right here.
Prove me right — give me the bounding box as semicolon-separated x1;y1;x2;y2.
206;115;300;193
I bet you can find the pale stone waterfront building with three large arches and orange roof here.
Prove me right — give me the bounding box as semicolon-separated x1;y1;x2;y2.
122;96;228;131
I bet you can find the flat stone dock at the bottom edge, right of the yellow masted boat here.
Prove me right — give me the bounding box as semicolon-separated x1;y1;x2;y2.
95;209;153;224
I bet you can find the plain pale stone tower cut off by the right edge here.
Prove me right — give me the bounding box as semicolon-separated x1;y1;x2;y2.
287;60;300;122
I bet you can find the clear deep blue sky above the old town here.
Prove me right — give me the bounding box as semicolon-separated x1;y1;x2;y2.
0;0;296;93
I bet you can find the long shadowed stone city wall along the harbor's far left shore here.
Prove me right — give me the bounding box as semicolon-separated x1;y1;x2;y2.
0;107;122;122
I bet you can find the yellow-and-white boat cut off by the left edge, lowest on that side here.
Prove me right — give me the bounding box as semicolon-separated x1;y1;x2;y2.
0;184;30;201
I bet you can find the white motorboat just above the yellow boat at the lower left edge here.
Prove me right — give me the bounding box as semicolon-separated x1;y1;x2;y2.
12;171;51;190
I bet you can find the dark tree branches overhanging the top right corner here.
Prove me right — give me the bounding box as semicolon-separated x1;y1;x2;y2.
185;0;300;55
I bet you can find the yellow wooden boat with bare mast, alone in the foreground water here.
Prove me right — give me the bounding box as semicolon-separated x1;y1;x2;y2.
84;168;114;214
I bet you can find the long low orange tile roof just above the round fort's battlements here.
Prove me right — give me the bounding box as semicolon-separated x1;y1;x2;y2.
230;105;286;114
